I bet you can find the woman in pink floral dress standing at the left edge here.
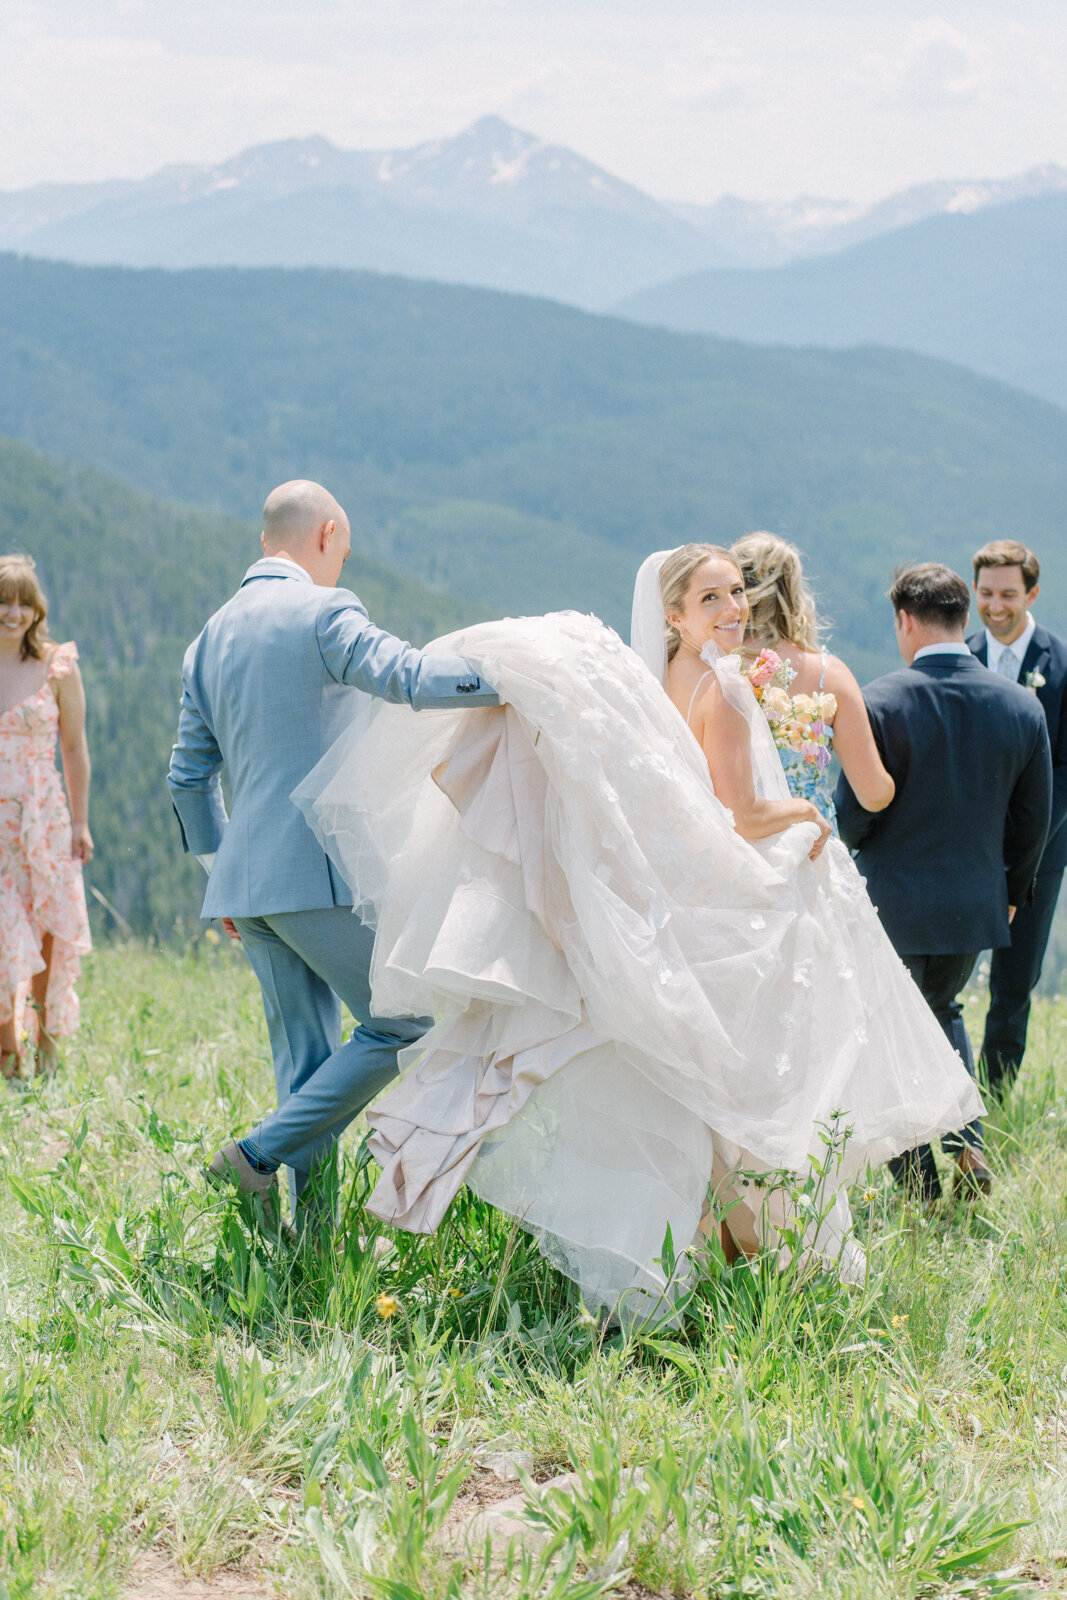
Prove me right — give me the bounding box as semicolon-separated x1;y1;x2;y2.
0;555;93;1077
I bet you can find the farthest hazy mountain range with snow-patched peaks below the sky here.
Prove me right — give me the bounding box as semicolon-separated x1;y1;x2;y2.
0;117;1067;309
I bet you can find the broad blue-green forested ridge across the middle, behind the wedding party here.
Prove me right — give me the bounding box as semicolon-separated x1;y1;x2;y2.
0;256;1067;674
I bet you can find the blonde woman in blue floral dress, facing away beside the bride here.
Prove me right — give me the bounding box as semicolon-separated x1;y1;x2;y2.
733;533;894;834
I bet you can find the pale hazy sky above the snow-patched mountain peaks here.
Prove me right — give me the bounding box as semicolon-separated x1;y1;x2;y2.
0;0;1067;200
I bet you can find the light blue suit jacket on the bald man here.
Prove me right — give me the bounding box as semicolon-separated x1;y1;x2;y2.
168;558;498;917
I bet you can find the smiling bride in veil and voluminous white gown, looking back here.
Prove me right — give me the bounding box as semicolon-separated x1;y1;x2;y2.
296;546;982;1315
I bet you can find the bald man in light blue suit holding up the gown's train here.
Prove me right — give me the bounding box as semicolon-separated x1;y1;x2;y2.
168;480;498;1206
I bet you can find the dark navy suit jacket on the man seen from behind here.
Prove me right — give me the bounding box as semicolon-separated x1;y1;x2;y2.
837;654;1053;955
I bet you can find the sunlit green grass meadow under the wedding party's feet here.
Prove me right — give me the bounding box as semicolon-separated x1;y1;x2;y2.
0;939;1067;1600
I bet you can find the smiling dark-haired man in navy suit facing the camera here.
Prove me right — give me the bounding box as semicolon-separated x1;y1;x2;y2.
968;539;1067;1096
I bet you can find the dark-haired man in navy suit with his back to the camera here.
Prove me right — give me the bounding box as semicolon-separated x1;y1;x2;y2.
837;562;1053;1200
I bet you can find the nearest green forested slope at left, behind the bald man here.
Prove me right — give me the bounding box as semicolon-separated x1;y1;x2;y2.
0;438;470;936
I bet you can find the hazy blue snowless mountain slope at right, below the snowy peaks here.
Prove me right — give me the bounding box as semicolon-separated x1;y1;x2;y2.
616;194;1067;406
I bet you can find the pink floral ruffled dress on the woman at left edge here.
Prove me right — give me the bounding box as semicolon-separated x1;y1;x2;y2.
0;643;90;1037
